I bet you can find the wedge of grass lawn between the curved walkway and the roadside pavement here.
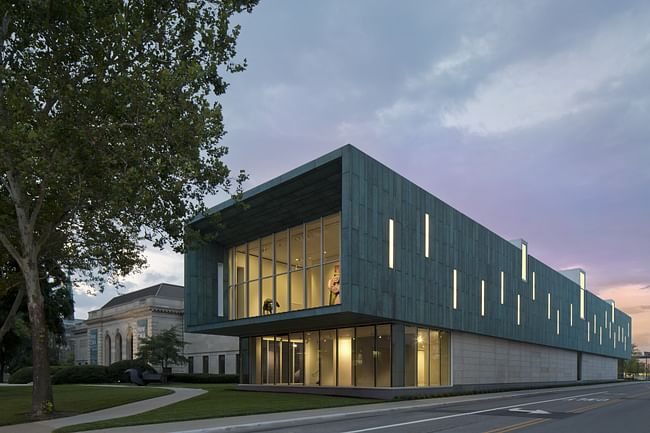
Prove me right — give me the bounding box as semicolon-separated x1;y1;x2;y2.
56;384;378;433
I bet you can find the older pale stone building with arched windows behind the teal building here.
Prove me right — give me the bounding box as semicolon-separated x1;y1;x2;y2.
66;283;239;374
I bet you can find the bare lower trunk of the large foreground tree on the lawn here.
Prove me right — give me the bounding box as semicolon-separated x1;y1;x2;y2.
23;260;54;418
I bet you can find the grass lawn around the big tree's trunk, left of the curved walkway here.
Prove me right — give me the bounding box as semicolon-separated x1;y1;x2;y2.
0;385;171;425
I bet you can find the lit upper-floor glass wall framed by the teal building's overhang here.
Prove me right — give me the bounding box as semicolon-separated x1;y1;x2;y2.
228;213;341;319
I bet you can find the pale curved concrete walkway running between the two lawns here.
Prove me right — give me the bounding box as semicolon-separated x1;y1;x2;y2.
0;385;206;433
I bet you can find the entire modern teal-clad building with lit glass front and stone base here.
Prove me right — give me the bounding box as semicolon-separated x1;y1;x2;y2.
185;145;631;395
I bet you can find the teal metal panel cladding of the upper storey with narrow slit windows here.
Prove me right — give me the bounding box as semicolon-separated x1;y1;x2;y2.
185;145;631;360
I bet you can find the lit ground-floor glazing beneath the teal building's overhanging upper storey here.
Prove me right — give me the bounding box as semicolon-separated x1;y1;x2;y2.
248;324;451;387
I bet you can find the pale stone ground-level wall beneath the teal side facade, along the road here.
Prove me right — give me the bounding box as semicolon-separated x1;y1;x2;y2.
452;332;576;385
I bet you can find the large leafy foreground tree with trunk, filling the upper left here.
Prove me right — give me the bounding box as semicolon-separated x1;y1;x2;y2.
0;0;257;417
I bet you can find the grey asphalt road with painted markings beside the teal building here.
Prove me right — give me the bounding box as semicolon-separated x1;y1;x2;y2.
221;383;650;433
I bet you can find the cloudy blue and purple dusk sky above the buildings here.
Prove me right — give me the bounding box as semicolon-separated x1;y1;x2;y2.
72;0;650;351
